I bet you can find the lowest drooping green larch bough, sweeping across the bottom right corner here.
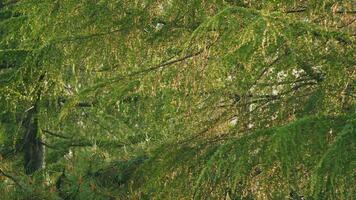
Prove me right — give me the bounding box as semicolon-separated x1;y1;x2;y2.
124;115;355;199
